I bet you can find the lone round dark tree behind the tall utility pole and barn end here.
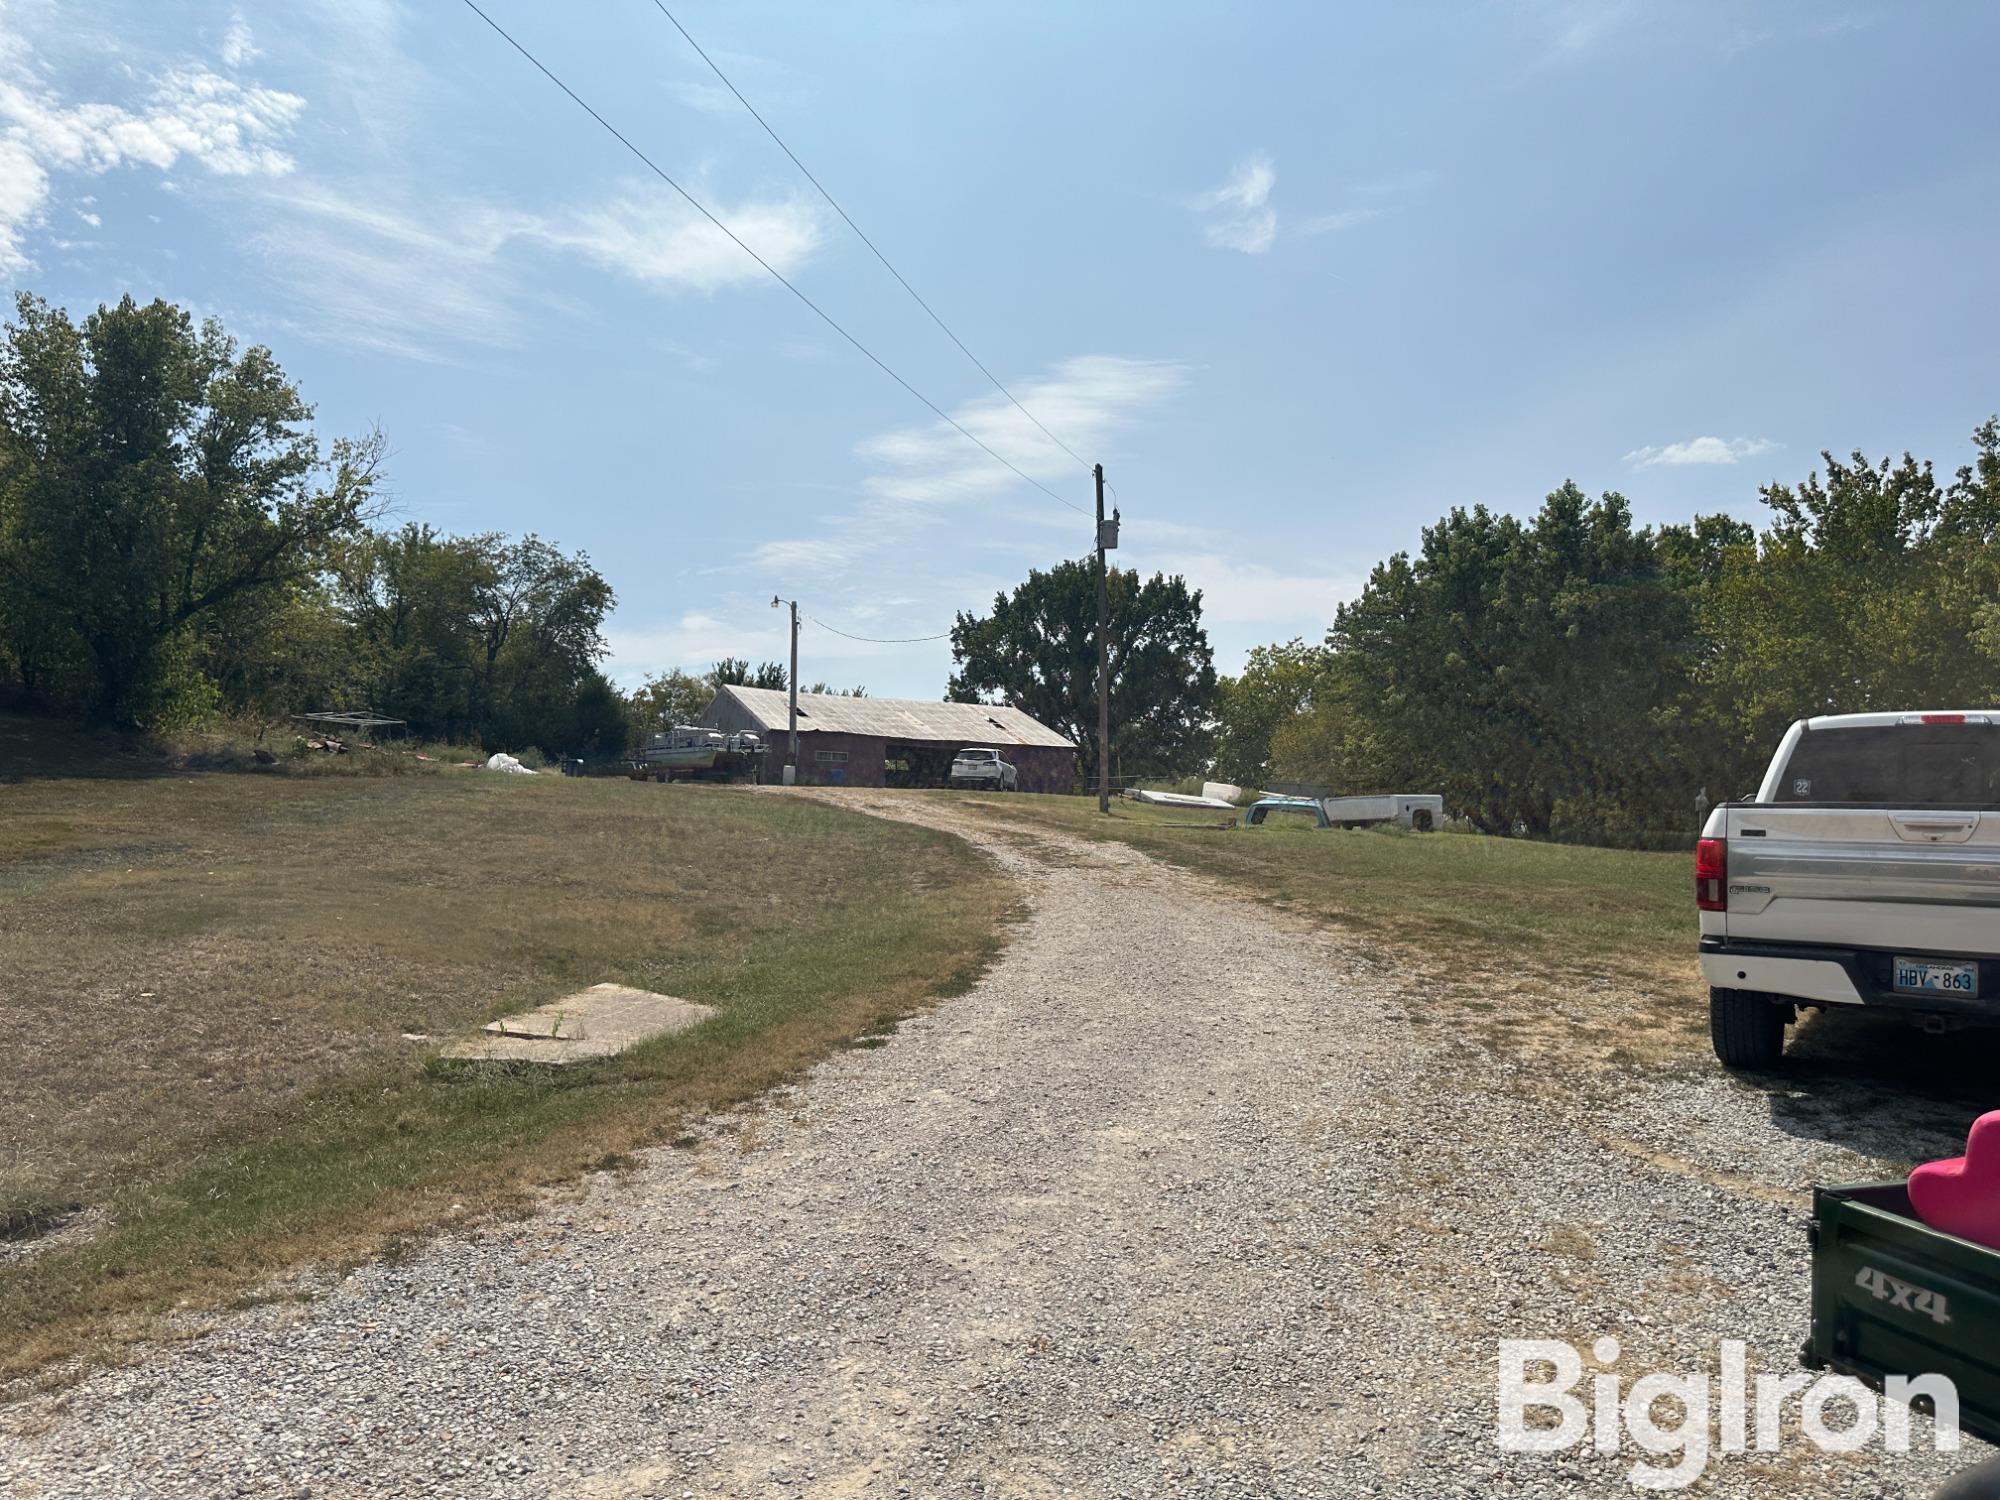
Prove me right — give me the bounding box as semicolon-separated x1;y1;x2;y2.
946;558;1216;780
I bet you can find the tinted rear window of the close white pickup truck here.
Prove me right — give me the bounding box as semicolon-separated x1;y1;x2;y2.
1778;724;2000;808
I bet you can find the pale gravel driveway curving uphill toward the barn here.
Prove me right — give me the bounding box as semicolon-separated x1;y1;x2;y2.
0;794;1984;1500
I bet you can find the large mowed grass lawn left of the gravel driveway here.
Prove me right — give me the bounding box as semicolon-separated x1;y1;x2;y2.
0;716;1012;1372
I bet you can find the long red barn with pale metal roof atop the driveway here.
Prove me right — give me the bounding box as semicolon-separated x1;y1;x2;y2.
702;688;1076;792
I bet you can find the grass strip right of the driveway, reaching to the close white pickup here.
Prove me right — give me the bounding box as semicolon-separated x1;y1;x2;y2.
960;796;1708;1072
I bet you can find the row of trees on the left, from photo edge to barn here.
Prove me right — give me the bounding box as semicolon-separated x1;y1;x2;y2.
0;294;862;756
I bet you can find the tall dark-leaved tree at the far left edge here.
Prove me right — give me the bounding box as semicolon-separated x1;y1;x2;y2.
0;292;382;722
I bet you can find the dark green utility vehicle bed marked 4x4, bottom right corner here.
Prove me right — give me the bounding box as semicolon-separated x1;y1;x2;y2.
1802;1182;2000;1500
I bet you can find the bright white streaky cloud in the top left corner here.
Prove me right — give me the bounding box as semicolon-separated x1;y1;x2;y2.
0;58;306;272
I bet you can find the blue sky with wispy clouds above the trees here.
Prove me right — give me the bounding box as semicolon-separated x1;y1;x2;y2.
0;0;2000;698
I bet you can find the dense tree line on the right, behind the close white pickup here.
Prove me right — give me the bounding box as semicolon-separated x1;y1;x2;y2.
1216;420;2000;846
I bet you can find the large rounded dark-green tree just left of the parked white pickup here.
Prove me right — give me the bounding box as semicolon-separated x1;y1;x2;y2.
1328;484;1698;840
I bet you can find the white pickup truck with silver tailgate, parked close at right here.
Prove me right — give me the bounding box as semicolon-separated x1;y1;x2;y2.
1694;710;2000;1068
